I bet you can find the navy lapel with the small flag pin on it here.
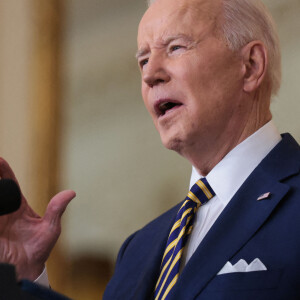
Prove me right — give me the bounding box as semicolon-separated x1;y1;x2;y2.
170;136;300;299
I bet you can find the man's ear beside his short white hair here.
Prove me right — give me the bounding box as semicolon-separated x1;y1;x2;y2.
241;41;268;93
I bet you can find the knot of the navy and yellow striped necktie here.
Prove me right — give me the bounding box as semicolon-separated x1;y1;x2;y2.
186;178;215;207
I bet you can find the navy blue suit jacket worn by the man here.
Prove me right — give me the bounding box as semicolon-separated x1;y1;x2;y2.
103;134;300;300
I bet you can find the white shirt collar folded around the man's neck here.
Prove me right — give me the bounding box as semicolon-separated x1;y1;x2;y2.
190;120;281;204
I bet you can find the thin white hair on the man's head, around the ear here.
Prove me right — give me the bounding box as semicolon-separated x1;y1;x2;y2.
148;0;281;95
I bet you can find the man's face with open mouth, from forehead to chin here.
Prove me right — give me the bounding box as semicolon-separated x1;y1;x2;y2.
137;0;243;156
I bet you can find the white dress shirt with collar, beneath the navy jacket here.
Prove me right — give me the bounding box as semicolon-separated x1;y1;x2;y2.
180;121;281;270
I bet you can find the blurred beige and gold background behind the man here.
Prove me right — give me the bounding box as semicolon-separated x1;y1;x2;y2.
0;0;300;300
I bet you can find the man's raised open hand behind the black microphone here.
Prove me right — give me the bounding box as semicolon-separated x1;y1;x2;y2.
0;158;75;280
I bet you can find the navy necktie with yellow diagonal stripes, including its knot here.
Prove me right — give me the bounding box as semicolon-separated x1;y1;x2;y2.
155;178;215;300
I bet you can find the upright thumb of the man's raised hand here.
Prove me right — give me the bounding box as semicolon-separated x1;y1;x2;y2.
44;190;76;225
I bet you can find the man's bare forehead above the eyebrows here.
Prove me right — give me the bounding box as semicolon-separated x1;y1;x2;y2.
138;0;222;43
